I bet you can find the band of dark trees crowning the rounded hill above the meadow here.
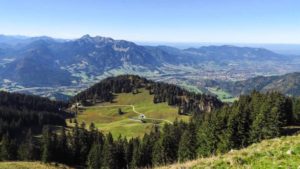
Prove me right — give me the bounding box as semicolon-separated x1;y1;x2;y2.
72;75;222;114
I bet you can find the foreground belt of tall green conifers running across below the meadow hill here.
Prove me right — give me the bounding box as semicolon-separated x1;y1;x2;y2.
0;90;300;169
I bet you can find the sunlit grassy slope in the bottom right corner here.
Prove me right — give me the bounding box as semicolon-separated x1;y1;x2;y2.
157;134;300;169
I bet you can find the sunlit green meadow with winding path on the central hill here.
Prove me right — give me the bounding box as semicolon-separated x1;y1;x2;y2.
67;89;189;138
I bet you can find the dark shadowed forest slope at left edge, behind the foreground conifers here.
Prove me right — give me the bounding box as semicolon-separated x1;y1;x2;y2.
0;92;67;138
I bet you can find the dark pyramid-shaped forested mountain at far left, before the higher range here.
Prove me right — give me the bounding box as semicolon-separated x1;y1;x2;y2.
0;42;72;87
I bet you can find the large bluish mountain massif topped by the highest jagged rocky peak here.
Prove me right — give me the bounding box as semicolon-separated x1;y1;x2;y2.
0;35;176;87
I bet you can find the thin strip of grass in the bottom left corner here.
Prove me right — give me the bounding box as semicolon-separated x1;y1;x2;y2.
0;162;72;169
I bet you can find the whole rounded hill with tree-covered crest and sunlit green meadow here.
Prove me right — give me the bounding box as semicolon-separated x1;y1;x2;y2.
69;75;222;138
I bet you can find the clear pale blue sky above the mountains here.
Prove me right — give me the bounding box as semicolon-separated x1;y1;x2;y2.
0;0;300;44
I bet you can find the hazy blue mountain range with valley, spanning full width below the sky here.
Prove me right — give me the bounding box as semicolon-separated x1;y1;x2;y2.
0;35;300;99
